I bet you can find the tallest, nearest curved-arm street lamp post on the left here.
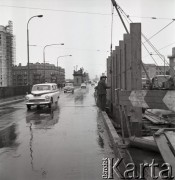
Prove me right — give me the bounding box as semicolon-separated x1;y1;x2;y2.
27;15;43;85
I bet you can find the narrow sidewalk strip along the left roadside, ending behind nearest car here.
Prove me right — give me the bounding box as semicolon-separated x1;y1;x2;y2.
0;95;25;106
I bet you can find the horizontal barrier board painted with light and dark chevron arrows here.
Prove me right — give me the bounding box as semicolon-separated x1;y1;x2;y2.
119;90;175;112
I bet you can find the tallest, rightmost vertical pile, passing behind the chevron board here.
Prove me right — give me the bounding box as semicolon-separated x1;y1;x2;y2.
130;23;142;136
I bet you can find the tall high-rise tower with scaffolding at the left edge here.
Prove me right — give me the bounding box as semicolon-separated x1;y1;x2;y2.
0;21;15;87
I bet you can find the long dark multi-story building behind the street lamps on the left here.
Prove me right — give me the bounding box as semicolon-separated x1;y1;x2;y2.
13;63;65;86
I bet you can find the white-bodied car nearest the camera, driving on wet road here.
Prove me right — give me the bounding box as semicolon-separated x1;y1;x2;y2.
25;83;60;110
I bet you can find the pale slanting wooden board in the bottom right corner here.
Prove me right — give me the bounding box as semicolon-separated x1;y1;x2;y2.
154;133;175;176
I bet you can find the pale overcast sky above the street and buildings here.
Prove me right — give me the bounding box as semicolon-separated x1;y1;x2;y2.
0;0;175;78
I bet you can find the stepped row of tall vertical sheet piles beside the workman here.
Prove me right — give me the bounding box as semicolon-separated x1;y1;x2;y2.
107;23;142;136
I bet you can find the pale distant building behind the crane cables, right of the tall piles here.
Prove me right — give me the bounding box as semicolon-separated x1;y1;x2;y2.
142;64;170;79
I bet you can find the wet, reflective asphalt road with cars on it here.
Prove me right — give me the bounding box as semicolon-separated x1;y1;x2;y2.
0;86;117;180
